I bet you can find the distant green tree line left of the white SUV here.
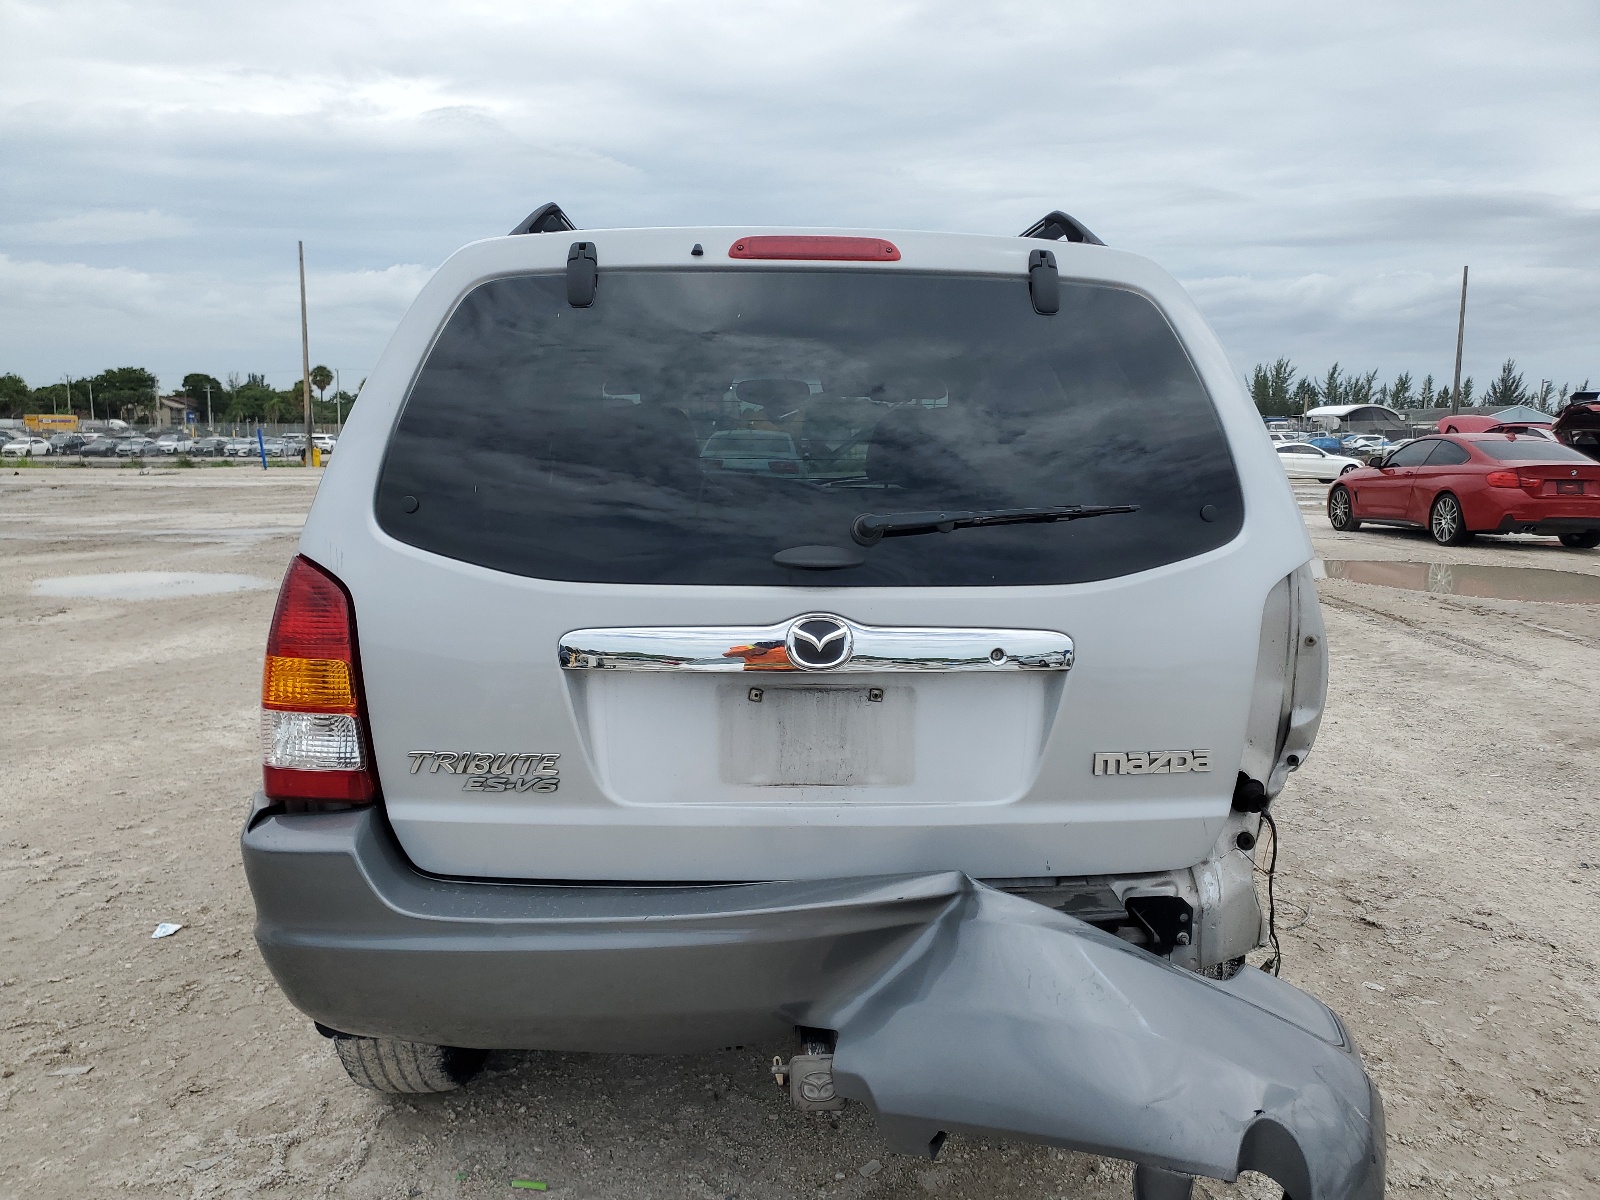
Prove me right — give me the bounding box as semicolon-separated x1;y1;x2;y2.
0;366;355;424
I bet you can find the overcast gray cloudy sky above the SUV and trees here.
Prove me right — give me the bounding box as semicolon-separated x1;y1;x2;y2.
0;0;1600;390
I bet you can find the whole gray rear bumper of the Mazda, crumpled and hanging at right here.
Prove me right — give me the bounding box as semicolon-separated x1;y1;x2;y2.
243;810;1384;1200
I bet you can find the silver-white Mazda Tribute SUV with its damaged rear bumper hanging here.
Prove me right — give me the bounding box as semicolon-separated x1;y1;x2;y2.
243;205;1382;1200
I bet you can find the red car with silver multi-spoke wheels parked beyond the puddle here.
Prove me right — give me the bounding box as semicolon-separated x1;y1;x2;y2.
1328;434;1600;549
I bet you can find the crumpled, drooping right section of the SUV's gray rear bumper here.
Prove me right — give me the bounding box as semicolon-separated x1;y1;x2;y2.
774;877;1384;1200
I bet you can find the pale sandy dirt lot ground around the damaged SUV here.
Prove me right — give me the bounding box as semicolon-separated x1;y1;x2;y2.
0;469;1600;1200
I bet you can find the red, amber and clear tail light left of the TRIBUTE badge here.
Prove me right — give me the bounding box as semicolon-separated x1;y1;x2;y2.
261;557;378;805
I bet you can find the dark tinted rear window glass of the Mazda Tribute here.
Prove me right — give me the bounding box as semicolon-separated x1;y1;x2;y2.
378;269;1243;587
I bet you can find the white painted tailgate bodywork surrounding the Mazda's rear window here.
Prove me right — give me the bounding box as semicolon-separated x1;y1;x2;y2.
301;229;1310;882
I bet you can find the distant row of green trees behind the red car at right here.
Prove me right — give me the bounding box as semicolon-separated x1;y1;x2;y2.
1250;358;1589;416
